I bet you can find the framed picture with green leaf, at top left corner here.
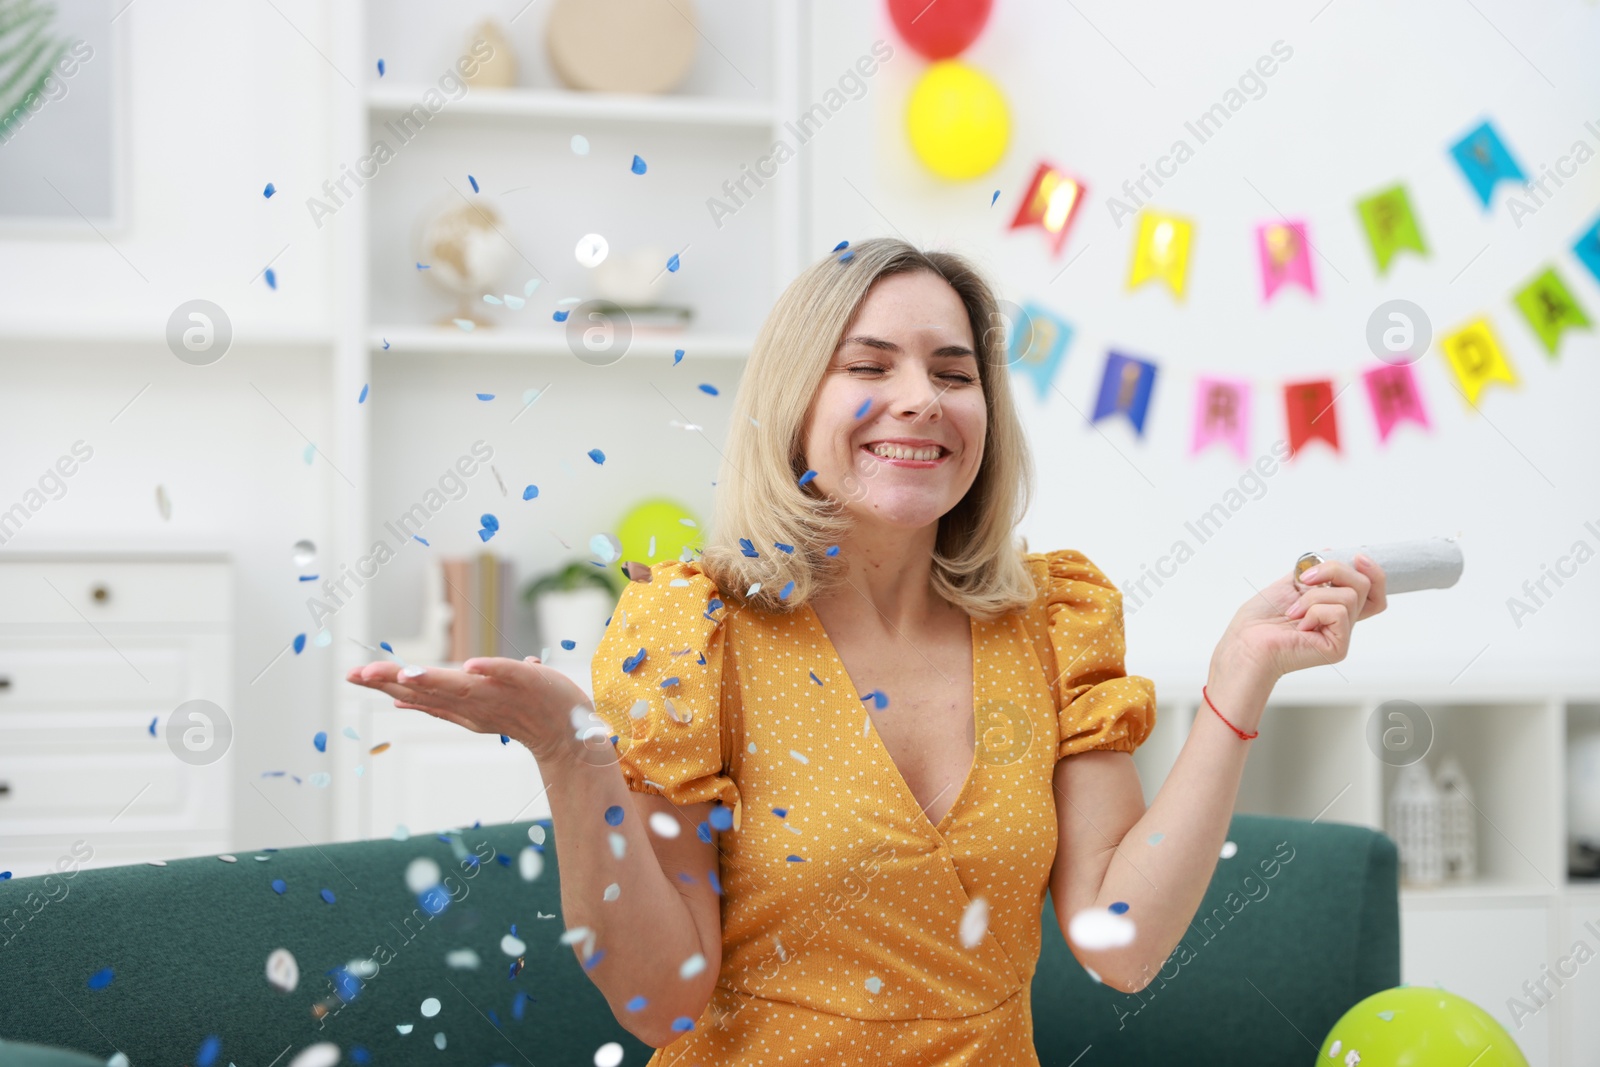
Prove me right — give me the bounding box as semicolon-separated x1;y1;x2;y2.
0;0;131;237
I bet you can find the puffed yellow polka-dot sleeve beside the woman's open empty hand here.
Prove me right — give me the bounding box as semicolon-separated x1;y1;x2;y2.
590;560;741;827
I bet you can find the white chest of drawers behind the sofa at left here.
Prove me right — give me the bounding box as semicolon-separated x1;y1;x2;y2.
0;552;234;877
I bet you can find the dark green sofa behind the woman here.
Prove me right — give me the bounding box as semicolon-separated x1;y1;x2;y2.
0;816;1400;1067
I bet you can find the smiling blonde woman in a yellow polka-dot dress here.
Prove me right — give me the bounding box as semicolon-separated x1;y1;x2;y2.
350;238;1384;1064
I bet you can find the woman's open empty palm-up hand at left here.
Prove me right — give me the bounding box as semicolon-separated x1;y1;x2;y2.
346;656;601;766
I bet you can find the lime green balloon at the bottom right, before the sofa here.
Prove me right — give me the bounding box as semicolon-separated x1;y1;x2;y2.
1317;985;1528;1067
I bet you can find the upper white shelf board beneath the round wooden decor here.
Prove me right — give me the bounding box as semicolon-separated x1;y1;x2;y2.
366;85;776;131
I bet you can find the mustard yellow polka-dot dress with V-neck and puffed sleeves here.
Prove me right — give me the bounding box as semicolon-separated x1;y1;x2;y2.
592;549;1155;1067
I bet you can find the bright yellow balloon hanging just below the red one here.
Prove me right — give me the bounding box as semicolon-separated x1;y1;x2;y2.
906;59;1011;181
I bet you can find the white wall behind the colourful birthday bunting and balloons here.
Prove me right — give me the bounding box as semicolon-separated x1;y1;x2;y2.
806;0;1600;688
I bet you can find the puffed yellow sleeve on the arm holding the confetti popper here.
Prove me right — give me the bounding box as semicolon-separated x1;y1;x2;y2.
1027;549;1155;760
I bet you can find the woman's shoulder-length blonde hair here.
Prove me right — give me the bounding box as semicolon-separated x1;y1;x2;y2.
701;237;1037;619
